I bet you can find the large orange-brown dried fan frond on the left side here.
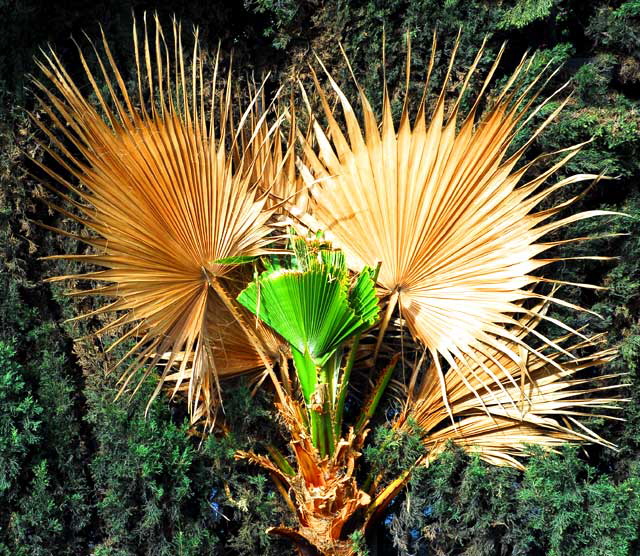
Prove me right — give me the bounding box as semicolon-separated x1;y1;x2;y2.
30;18;279;426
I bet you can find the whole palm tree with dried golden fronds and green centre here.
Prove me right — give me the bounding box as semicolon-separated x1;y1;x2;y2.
36;20;620;555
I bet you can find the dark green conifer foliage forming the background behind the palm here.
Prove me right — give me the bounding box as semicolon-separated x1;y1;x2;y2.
0;0;640;556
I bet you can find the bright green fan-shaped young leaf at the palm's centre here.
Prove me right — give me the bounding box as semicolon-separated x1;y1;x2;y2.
238;239;379;404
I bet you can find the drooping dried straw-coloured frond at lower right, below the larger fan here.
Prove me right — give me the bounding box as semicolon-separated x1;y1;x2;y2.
396;306;623;469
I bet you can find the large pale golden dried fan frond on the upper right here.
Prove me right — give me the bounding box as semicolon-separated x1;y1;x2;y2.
302;38;620;416
